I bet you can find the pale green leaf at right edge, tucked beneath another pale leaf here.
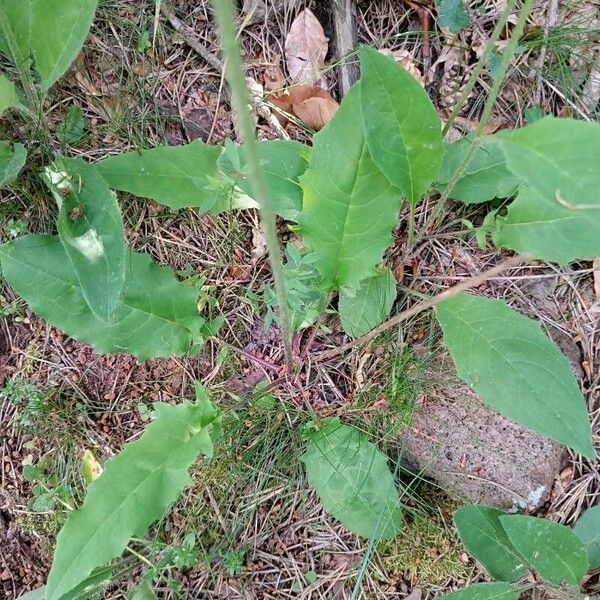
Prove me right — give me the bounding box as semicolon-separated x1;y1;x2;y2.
492;187;600;265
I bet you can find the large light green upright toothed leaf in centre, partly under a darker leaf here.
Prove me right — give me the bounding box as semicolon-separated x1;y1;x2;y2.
298;84;400;289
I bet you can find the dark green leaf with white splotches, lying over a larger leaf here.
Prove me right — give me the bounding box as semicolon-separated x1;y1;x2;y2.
46;158;125;321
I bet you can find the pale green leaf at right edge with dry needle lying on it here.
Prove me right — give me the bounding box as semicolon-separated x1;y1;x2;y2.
488;117;600;211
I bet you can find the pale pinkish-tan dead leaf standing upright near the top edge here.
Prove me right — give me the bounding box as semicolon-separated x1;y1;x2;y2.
285;8;329;87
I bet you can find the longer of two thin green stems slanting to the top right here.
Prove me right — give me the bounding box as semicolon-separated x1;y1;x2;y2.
421;0;533;237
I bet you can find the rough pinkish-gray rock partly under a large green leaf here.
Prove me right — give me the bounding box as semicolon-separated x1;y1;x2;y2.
402;361;565;511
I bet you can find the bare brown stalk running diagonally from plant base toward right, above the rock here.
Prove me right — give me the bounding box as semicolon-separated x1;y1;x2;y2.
313;254;527;362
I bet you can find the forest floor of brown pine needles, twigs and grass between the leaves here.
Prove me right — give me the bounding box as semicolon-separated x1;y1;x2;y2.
0;0;600;600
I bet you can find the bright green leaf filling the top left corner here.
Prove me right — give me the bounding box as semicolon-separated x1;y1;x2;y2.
0;0;98;91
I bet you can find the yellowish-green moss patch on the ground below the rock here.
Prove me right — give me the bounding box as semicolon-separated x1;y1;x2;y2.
377;512;468;586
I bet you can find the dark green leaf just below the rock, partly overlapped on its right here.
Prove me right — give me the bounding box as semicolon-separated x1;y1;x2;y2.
454;504;527;581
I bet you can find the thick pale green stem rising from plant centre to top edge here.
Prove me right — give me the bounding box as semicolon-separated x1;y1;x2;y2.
212;0;294;373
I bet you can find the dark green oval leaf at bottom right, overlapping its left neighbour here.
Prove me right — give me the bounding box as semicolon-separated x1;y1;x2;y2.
500;515;588;586
